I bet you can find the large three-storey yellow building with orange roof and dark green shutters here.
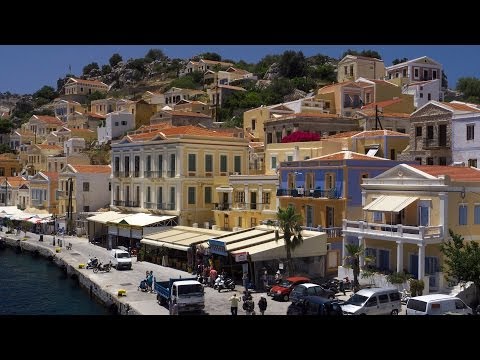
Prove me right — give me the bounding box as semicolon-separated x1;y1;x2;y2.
111;126;248;226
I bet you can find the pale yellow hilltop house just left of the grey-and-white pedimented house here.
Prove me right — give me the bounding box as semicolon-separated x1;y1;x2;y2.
337;55;385;82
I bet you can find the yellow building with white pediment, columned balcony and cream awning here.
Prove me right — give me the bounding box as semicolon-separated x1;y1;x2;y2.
343;164;480;294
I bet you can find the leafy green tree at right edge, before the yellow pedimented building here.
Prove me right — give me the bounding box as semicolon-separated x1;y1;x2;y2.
440;229;480;287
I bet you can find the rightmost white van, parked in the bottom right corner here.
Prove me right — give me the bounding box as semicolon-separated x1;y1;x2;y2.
407;294;473;315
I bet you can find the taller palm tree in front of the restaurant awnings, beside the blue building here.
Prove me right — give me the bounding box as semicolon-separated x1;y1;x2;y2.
275;206;303;275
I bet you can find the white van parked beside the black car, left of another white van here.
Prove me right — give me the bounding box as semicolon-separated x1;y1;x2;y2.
341;288;402;315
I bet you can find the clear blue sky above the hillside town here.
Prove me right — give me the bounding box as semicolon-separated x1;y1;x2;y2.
0;45;480;94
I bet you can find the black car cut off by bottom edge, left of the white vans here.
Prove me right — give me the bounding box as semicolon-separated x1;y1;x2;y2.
287;296;343;316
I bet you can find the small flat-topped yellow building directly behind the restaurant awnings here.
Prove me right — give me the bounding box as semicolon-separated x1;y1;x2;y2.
214;175;278;230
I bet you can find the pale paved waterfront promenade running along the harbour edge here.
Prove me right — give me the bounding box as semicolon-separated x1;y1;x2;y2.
0;232;290;315
